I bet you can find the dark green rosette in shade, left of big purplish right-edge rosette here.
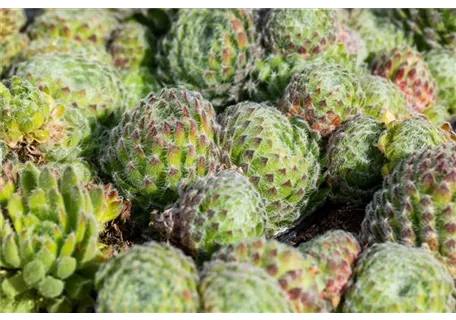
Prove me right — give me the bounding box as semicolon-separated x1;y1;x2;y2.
326;115;386;201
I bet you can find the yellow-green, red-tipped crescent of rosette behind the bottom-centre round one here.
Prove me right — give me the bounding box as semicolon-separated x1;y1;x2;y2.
212;238;331;313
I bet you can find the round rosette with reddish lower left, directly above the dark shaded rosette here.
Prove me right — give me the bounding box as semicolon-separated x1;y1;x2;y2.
279;60;364;136
